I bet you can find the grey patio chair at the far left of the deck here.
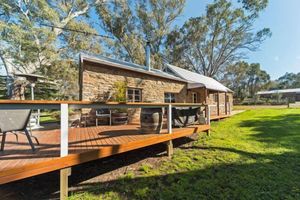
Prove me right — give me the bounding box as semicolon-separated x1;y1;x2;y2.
0;109;39;151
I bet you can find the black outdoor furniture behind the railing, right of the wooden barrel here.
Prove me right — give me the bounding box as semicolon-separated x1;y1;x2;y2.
172;107;200;127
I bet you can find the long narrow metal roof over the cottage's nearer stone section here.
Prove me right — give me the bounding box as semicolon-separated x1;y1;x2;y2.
79;53;187;83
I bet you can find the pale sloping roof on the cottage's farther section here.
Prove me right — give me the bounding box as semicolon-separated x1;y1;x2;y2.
166;64;232;92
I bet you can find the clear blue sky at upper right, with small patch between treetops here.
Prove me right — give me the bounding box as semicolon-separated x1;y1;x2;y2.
176;0;300;79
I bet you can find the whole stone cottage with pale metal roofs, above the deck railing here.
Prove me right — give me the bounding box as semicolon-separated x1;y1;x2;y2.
79;54;233;122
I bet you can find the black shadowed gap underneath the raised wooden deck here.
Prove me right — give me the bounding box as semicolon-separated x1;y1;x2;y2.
0;137;194;200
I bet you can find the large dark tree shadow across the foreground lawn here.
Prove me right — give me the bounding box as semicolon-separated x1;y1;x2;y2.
72;149;300;199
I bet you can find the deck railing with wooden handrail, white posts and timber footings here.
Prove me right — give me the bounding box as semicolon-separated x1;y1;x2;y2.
0;100;210;199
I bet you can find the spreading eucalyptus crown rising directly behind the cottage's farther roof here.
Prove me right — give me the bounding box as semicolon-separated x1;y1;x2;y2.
167;0;271;77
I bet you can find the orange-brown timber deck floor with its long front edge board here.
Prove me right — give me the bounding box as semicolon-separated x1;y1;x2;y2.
0;125;210;184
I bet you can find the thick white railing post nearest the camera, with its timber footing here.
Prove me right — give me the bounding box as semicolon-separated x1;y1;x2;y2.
60;104;70;200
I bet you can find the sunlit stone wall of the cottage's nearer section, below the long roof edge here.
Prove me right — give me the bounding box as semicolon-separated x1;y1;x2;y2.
80;62;187;123
